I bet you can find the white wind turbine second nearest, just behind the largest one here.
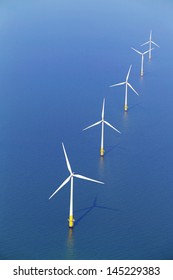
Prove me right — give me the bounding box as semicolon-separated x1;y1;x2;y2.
83;98;121;157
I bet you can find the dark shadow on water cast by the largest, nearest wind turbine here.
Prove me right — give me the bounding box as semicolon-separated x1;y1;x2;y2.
75;196;118;226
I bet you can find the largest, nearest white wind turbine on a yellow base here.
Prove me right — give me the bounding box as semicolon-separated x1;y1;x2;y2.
49;143;104;228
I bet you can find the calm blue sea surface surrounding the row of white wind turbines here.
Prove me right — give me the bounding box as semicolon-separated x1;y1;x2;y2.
0;0;173;260
